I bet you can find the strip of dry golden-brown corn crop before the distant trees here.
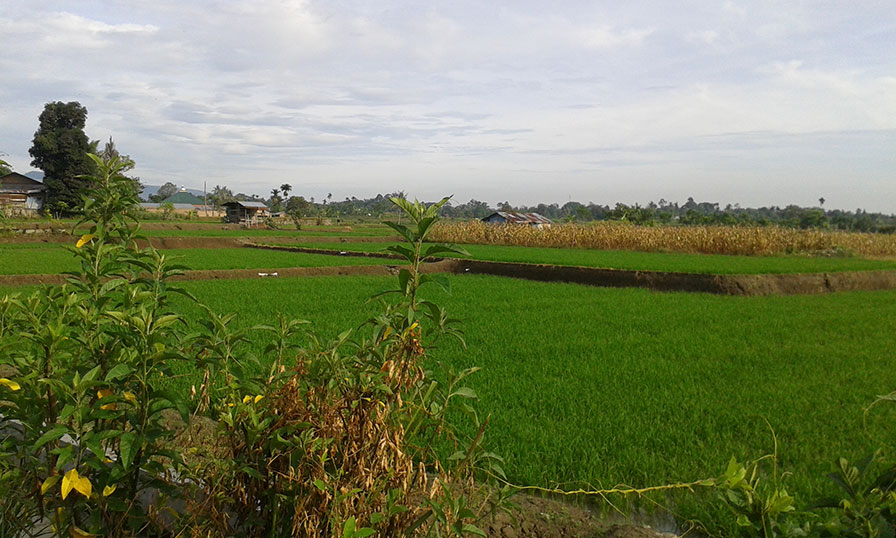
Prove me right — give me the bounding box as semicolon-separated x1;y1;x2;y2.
430;221;896;256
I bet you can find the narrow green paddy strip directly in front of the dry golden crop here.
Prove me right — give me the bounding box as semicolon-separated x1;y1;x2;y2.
280;243;896;274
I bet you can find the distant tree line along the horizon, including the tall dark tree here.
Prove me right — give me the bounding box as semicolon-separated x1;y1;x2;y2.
12;101;896;233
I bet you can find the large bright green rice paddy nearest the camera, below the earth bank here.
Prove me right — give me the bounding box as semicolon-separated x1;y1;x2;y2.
152;276;896;510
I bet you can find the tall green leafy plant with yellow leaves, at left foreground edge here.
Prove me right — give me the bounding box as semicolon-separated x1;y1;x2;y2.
0;155;193;536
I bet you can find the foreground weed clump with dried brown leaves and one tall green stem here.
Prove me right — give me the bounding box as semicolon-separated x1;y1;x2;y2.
190;199;509;536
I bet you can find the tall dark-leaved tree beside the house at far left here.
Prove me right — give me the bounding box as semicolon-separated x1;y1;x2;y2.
28;101;96;213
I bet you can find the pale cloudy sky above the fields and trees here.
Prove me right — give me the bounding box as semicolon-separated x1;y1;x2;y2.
0;0;896;214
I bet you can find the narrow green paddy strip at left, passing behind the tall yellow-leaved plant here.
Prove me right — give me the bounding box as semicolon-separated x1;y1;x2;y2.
0;245;383;275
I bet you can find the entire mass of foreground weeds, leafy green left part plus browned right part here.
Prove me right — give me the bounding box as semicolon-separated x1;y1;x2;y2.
0;156;501;537
